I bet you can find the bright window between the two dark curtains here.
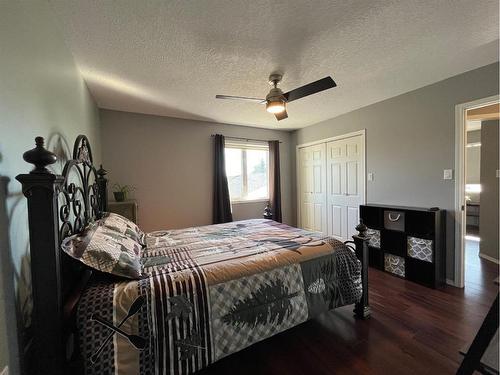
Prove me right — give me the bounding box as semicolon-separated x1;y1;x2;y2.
225;140;269;202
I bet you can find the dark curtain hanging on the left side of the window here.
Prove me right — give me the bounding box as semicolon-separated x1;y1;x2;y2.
213;134;233;224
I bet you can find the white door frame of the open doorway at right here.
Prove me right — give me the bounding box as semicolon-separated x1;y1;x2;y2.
453;95;500;288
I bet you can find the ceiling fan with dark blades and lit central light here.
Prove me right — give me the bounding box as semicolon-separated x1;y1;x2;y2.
215;73;337;121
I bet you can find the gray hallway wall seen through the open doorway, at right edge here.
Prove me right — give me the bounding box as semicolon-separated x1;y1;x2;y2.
479;120;499;260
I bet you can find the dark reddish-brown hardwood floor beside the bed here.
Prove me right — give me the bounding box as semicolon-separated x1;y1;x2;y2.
200;247;498;375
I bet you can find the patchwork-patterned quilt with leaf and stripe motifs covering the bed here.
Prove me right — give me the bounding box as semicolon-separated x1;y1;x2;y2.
77;219;362;375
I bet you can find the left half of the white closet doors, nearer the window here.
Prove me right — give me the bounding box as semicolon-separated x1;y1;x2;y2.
298;143;327;233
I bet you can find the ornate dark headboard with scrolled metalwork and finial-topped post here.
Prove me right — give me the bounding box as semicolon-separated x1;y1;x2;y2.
16;135;107;374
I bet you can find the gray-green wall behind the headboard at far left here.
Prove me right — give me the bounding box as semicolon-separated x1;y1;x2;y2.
0;0;100;374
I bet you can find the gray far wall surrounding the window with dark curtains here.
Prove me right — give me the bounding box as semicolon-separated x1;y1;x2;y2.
100;110;293;231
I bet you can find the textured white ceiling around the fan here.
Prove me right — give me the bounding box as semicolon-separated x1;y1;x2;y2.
51;0;499;129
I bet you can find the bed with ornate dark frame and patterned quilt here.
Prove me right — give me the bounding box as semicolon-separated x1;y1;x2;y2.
17;136;370;375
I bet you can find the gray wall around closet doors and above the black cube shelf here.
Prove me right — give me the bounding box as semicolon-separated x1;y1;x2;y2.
291;63;498;279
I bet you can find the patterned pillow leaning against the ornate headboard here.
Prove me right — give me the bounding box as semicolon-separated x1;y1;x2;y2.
61;222;142;279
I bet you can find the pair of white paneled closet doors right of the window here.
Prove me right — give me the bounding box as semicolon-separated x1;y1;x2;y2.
298;135;365;241
